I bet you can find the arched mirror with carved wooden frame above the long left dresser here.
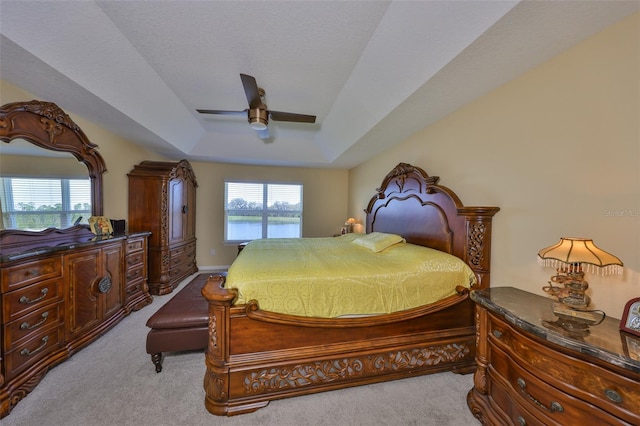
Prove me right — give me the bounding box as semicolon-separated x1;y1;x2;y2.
0;100;106;250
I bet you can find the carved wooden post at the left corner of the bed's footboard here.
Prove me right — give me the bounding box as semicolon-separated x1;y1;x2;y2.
202;275;236;415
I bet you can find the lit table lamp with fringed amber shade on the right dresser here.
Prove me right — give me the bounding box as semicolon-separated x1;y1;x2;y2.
538;238;623;323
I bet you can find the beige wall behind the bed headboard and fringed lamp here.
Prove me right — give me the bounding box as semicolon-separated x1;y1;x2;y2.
349;14;640;318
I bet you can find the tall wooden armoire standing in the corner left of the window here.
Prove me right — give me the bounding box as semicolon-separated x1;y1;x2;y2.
128;160;198;295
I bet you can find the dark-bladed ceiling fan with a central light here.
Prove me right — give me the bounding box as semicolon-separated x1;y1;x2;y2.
196;74;316;139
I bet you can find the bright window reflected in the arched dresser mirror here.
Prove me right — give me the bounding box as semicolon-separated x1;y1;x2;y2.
0;177;91;231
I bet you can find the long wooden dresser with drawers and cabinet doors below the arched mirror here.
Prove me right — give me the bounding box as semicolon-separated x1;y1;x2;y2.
0;227;153;417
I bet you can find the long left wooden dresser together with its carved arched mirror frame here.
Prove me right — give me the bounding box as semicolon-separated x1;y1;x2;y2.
0;100;153;416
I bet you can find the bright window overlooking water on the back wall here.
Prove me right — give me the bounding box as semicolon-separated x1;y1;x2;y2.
224;182;302;243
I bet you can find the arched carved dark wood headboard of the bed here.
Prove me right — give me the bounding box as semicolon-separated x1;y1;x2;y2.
365;163;500;288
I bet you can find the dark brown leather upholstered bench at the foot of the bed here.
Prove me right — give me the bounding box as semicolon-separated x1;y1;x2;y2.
147;272;224;373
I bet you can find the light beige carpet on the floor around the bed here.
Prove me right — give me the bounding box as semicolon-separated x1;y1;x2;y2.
6;275;479;426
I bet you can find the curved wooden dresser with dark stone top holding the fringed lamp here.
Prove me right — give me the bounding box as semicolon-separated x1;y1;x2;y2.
467;287;640;425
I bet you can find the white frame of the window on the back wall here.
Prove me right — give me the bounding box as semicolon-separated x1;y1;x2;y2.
223;179;304;245
